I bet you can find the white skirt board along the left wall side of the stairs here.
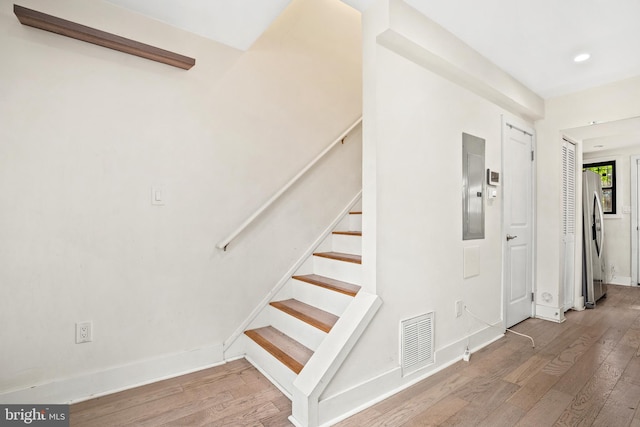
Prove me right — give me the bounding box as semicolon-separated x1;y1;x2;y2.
223;190;362;360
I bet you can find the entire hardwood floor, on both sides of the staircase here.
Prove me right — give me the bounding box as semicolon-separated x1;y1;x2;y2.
70;286;640;427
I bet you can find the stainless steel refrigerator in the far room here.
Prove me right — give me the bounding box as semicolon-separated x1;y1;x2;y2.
582;170;607;308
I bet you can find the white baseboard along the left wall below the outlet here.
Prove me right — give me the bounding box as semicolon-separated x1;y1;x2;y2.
0;345;225;404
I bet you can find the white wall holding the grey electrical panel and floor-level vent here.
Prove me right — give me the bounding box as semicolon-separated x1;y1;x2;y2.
320;1;531;421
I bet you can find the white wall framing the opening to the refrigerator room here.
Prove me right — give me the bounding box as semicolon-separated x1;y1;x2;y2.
536;77;640;321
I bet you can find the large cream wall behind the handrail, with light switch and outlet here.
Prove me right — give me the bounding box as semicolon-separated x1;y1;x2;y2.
0;0;361;402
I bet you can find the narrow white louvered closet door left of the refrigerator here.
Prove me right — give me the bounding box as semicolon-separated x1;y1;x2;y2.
562;140;576;311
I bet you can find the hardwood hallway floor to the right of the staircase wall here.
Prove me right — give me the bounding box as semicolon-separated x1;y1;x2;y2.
338;286;640;427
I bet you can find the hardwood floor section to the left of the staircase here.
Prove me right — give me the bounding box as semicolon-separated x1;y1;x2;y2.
69;359;291;427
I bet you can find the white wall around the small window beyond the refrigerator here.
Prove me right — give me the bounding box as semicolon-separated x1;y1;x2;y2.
582;146;640;285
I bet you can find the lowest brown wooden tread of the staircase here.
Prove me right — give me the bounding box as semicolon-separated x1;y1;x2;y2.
244;326;313;374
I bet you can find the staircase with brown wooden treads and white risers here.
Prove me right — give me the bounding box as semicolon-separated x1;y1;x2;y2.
244;206;362;405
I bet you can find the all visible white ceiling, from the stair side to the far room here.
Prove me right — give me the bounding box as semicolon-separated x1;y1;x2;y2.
107;0;640;151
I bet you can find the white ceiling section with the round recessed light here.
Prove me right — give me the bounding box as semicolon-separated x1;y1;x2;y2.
406;0;640;98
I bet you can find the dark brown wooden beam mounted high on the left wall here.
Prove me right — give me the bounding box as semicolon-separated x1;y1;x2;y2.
13;4;196;70
